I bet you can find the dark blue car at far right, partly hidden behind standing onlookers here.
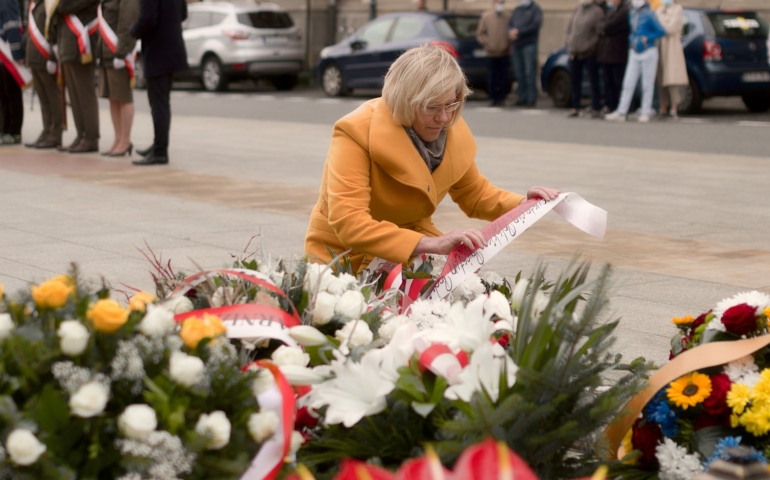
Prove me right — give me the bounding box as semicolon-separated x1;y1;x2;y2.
540;8;770;113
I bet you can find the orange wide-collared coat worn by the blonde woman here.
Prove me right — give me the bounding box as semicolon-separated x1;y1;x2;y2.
305;98;524;271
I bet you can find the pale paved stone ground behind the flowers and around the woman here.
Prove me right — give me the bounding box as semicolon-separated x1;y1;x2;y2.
0;100;770;363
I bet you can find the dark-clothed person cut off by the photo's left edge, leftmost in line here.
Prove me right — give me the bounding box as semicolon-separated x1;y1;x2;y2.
0;0;24;145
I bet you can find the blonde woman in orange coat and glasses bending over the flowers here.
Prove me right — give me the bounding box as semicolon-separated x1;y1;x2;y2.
305;45;559;271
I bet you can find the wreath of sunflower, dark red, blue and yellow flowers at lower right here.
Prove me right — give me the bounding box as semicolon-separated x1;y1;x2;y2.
616;291;770;480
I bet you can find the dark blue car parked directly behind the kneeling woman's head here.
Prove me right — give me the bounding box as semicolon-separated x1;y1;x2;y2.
316;12;496;96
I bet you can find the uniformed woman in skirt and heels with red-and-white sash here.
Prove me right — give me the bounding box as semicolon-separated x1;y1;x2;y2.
97;0;139;157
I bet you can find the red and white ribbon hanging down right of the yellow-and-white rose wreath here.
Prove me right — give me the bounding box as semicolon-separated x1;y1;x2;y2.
241;360;297;480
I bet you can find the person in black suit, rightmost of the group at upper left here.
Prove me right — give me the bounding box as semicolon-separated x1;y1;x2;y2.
131;0;189;165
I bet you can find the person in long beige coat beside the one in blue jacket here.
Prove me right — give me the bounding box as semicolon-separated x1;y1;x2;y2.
655;0;688;118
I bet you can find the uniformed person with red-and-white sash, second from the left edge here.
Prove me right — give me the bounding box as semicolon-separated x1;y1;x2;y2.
24;0;62;149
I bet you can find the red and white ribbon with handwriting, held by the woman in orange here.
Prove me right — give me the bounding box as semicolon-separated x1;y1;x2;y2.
427;192;607;300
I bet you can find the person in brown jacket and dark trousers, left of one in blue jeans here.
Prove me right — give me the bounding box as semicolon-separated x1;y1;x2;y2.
476;0;509;107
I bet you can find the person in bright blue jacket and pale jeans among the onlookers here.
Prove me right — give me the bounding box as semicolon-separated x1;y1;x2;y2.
604;0;666;123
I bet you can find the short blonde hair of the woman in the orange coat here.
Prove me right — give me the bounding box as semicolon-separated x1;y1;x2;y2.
382;44;471;128
